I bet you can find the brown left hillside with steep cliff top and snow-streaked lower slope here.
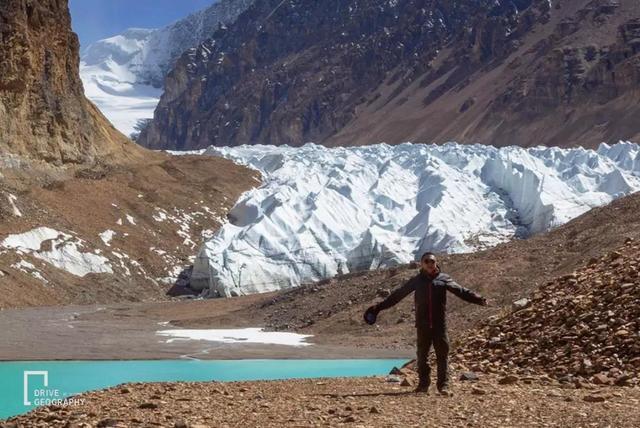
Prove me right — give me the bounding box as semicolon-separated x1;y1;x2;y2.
0;0;258;308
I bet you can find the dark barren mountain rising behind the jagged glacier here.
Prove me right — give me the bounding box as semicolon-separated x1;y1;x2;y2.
140;0;640;149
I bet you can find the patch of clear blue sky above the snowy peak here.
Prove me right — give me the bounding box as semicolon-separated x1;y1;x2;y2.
69;0;215;48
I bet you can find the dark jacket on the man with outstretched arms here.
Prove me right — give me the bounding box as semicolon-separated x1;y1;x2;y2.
375;271;483;333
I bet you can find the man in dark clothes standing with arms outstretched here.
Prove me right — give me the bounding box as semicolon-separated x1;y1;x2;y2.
364;252;487;395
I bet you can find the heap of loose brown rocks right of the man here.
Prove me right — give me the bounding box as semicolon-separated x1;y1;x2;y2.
458;238;640;385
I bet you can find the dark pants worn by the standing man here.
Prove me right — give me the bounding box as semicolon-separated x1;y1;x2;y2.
417;328;449;388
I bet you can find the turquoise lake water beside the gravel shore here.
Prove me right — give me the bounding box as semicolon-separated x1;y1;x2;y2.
0;359;407;419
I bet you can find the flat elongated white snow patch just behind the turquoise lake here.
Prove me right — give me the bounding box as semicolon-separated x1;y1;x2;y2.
157;328;312;346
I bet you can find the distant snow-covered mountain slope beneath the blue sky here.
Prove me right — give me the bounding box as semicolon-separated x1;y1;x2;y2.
80;0;253;135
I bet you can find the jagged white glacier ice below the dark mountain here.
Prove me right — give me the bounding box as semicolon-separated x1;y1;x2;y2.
186;142;640;297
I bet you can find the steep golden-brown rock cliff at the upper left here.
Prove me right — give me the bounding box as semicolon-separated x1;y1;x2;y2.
0;0;139;163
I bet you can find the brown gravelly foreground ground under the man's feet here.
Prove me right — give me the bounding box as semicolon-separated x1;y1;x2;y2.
5;377;640;428
